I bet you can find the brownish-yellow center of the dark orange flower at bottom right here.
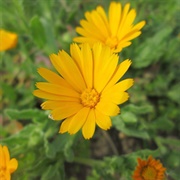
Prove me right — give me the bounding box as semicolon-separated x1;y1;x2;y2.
142;166;157;180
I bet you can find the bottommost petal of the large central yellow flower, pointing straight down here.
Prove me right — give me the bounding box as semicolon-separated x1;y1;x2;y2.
82;109;96;139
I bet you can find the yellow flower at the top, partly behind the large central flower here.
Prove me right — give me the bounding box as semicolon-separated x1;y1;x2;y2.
73;2;145;52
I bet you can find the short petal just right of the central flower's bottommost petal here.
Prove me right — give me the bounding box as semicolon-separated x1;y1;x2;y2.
95;109;112;130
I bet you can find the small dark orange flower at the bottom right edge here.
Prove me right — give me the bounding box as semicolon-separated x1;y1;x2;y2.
133;156;166;180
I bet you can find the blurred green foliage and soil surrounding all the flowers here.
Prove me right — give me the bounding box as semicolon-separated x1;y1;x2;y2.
0;0;180;180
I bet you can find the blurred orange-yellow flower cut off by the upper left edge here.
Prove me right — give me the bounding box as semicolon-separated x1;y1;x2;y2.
0;29;18;52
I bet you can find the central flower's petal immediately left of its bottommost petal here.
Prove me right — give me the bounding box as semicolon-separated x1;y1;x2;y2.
68;107;90;134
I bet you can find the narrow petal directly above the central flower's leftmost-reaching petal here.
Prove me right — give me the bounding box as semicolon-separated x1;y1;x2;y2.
36;82;79;98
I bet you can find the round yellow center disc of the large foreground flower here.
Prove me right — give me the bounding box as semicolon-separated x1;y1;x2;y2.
80;88;100;108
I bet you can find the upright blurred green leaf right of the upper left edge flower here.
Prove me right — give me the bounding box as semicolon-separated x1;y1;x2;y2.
30;15;46;48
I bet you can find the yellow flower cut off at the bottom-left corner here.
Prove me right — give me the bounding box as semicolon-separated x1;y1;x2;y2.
0;145;18;180
